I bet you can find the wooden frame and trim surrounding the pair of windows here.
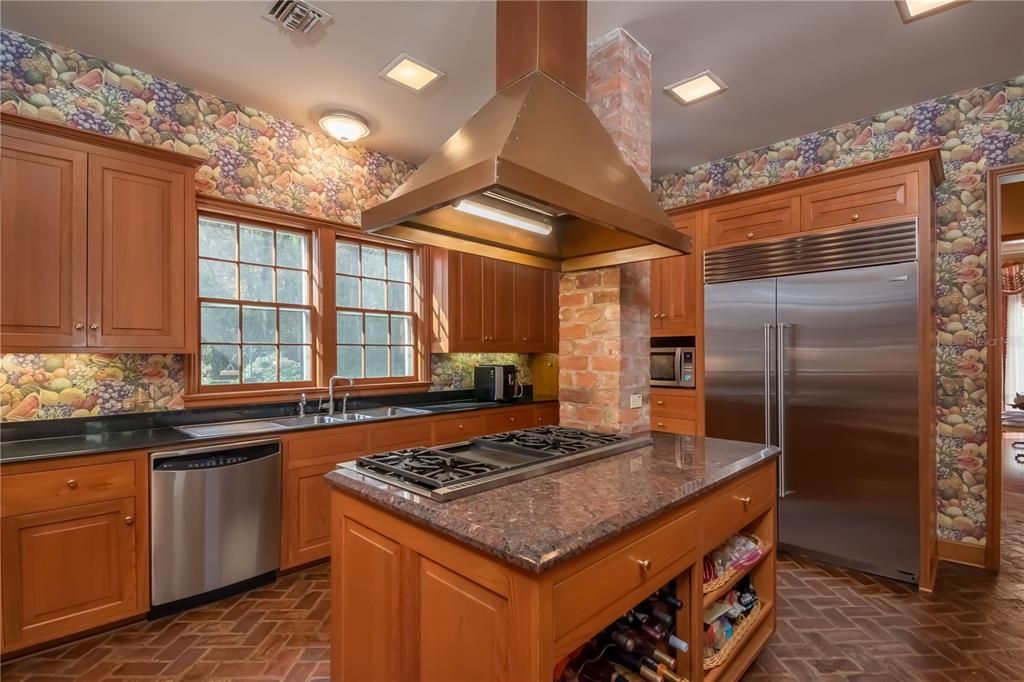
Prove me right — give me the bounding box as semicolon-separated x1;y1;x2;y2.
184;196;430;408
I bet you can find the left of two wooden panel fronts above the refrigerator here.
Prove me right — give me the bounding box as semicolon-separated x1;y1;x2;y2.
708;195;800;246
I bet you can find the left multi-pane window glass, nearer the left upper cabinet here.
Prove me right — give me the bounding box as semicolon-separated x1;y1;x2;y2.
199;216;313;387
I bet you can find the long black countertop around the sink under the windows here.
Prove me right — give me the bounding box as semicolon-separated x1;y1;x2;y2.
0;391;557;463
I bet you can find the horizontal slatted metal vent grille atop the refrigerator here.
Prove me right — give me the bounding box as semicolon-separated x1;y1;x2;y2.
705;221;918;284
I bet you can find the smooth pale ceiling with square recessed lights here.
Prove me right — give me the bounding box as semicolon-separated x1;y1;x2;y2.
0;0;1024;176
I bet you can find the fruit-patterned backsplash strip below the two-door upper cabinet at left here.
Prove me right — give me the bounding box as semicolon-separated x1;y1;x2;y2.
0;353;185;422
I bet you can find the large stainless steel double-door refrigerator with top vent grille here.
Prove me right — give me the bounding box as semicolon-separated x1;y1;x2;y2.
705;222;922;583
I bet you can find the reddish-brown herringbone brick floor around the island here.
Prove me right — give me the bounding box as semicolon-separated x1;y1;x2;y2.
0;495;1024;682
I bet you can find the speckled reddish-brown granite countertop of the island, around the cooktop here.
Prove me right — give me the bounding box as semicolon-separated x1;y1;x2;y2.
326;433;779;573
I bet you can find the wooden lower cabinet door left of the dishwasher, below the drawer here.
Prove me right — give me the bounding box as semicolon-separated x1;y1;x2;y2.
0;498;139;650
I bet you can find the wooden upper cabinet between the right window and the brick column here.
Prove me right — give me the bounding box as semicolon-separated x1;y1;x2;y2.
430;249;558;353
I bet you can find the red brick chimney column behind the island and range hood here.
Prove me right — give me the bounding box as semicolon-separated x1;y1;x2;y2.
558;29;651;433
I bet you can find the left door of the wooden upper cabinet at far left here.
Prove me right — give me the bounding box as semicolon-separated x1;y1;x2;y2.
0;135;88;350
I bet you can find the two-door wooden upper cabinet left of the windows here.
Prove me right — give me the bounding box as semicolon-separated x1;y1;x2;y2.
0;116;196;352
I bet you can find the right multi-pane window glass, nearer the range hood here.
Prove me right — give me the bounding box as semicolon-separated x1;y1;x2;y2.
335;240;416;379
